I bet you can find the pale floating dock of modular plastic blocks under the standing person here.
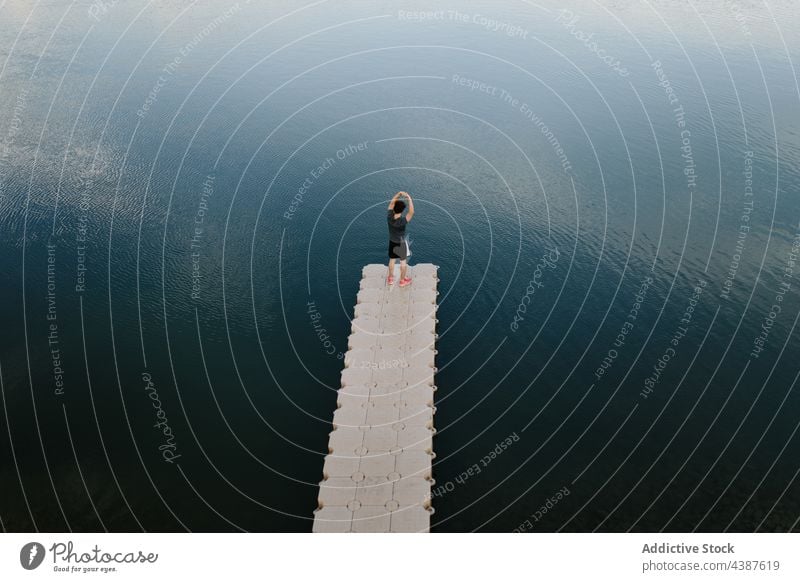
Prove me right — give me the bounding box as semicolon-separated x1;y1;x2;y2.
313;264;438;533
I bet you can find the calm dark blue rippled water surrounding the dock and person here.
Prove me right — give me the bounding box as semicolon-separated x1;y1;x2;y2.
0;0;800;531
